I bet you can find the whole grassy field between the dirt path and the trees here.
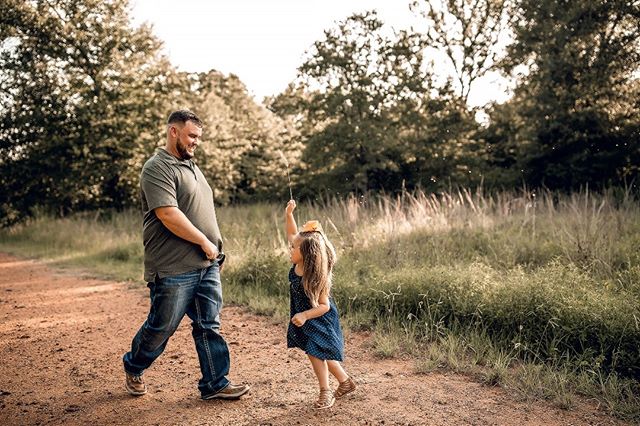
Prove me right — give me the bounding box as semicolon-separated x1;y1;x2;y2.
0;191;640;421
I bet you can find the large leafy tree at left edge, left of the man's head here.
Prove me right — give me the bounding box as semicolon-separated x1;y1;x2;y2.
0;0;178;224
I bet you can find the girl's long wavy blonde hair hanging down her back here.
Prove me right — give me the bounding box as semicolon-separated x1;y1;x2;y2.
299;231;336;308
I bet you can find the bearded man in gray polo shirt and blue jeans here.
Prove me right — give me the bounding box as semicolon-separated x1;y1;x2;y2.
123;110;249;399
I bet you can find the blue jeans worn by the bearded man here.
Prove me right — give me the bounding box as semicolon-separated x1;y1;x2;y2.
123;262;229;395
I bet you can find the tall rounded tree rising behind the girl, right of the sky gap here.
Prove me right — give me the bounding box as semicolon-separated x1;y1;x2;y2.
271;12;438;192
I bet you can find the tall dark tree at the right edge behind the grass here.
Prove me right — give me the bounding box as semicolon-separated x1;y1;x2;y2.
505;0;640;189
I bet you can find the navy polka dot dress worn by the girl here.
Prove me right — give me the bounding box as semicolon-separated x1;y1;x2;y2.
287;266;344;361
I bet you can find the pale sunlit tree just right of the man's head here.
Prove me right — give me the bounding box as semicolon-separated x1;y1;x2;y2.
183;71;300;203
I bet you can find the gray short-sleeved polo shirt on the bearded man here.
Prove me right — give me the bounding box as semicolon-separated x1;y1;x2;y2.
140;148;222;282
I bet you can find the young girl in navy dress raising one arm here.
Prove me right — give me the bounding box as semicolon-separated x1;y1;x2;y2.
285;200;356;409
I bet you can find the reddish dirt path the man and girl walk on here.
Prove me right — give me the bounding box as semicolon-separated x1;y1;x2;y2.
0;254;620;426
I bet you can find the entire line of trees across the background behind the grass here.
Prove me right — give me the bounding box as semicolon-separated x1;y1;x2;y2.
0;0;640;225
